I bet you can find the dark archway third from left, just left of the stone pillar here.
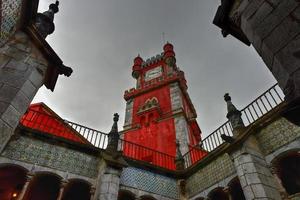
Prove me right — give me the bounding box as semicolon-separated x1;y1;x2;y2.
62;179;91;200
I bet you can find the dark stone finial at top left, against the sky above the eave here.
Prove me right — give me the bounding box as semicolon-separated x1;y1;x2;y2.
35;1;59;38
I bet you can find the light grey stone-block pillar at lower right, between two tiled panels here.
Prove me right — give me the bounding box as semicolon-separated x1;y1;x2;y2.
231;136;281;200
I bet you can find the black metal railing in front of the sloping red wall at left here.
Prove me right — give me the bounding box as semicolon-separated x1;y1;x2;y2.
20;109;108;149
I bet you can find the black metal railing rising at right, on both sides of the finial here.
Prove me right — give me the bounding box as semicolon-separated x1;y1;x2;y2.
183;84;284;167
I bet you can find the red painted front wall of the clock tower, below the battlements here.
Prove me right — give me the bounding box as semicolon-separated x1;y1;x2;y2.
124;85;176;169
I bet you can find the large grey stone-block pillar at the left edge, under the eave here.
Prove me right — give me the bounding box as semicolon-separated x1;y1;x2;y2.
0;31;47;152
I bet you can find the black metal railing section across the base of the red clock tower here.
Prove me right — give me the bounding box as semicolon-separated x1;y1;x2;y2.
118;139;176;170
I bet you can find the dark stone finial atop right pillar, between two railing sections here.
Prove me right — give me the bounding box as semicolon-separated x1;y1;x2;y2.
224;93;245;129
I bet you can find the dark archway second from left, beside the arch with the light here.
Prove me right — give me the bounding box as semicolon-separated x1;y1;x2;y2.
25;173;60;200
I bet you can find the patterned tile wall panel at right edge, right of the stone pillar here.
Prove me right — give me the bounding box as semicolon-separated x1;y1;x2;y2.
256;118;300;155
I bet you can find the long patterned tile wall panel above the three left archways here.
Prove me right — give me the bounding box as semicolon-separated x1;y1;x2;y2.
1;136;100;178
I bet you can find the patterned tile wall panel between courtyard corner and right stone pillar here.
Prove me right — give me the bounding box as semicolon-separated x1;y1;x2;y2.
187;153;236;197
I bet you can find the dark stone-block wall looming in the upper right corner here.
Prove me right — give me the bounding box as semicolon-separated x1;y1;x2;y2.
230;0;300;100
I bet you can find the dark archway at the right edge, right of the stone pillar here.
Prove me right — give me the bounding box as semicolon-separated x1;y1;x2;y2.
276;153;300;195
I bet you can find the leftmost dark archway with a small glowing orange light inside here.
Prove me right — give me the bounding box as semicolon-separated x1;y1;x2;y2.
0;165;27;200
